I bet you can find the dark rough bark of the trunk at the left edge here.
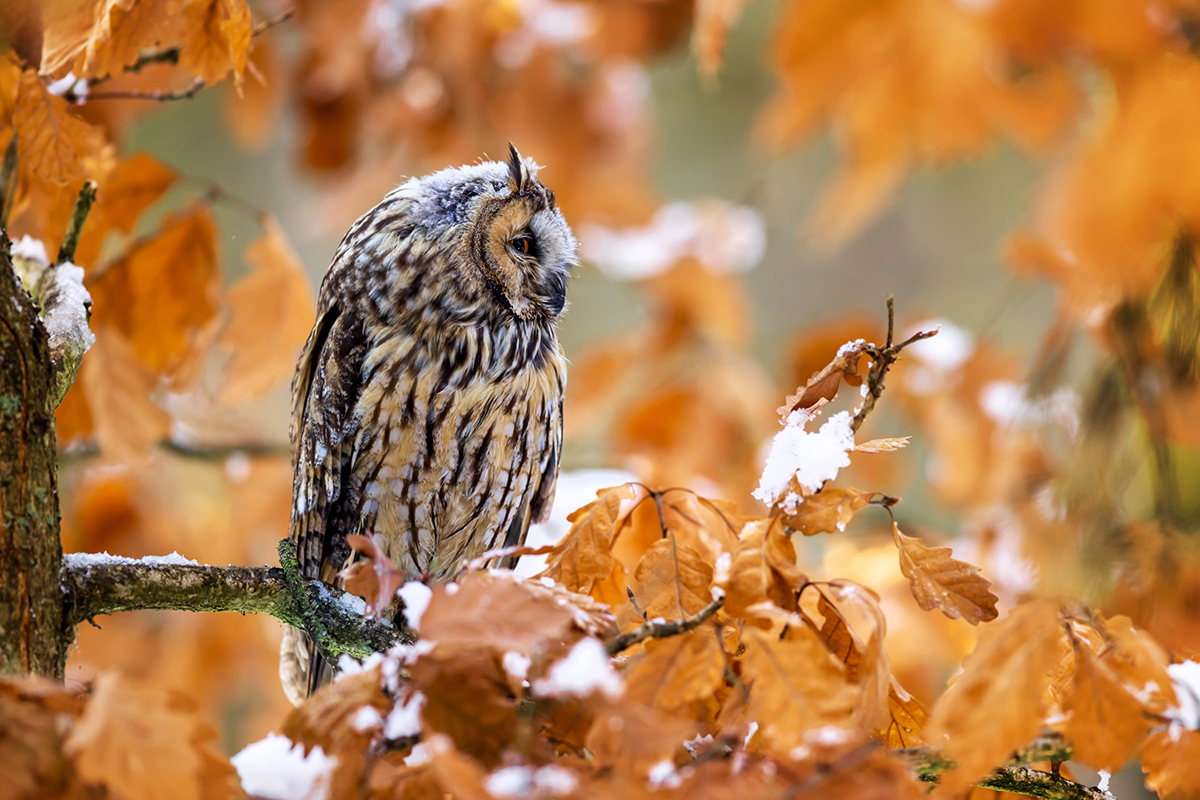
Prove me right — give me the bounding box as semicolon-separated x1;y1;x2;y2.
0;231;66;679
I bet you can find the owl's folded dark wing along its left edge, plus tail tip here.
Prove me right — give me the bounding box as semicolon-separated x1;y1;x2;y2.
284;299;366;694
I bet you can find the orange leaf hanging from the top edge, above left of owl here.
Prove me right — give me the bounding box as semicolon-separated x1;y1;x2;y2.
179;0;254;86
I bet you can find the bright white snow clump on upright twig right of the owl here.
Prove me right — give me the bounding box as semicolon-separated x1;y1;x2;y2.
754;409;854;513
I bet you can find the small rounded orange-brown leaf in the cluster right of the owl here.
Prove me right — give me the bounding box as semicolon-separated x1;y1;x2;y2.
634;536;713;619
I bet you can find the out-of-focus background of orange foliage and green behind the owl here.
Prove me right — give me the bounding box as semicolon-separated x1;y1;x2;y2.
13;0;1200;796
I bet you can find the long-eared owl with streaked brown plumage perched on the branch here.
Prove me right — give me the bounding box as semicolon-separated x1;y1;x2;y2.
280;145;577;703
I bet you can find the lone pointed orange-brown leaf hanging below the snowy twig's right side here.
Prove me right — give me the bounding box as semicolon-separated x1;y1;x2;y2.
892;522;1000;625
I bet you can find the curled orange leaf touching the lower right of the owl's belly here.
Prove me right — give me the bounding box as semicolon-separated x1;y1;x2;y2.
538;483;637;594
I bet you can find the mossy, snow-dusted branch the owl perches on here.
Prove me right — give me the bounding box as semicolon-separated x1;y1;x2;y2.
61;540;413;661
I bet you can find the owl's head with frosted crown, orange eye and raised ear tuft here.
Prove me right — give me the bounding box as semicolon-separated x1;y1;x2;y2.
403;144;578;321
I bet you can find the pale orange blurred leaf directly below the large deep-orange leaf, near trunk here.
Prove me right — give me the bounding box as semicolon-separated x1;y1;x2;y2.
79;327;170;462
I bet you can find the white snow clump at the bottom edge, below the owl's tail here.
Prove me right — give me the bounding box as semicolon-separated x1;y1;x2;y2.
229;733;337;800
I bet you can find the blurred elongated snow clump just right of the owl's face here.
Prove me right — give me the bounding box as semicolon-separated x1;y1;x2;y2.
580;201;767;281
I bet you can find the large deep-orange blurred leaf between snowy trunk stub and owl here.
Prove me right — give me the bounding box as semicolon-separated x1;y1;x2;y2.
88;205;221;377
